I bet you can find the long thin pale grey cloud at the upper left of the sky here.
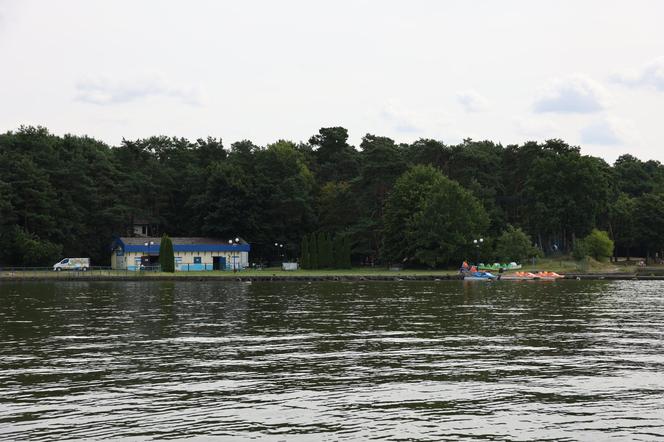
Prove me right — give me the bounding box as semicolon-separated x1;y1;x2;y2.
75;74;200;106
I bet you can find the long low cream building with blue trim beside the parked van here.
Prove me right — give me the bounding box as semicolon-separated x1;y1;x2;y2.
111;237;251;271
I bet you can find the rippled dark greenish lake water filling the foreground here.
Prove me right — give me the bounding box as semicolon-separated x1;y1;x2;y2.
0;281;664;441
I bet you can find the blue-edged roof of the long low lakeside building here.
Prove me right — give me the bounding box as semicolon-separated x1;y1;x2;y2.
113;237;251;255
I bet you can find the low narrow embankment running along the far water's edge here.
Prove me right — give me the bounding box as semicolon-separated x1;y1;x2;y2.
0;273;664;285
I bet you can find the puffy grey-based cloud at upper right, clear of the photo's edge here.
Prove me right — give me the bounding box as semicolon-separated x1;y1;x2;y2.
533;75;608;114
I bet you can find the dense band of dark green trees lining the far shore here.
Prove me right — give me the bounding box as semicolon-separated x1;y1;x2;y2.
0;127;664;266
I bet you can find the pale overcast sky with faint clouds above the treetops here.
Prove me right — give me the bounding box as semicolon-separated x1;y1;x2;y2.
0;0;664;162
